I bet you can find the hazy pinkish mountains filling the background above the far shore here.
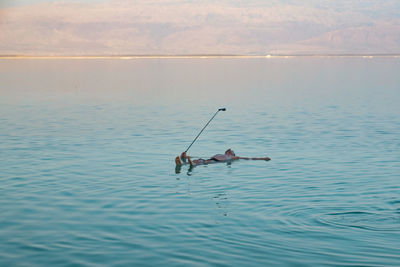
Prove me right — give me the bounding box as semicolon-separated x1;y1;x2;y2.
0;0;400;55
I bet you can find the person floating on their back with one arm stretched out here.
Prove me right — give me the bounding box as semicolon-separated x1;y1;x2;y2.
175;149;271;166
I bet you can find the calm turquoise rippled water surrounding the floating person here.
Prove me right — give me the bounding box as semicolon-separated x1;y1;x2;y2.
0;58;400;266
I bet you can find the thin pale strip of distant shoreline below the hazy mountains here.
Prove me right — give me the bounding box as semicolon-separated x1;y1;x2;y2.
0;54;400;59
